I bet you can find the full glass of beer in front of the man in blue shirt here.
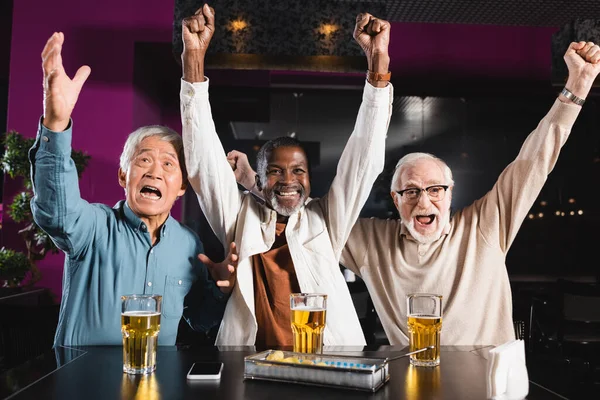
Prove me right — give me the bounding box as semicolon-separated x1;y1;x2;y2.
121;294;162;374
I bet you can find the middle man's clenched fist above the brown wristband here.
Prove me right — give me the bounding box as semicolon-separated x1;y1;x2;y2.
353;13;390;78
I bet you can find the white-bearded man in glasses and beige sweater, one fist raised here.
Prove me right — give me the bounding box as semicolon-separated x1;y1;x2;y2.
232;42;600;345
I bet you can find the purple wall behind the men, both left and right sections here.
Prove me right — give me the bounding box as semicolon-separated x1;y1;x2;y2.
3;0;557;297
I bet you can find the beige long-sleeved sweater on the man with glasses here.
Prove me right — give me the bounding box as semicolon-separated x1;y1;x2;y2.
341;99;581;345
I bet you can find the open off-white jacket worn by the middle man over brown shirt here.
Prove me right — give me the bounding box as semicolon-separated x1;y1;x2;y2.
180;80;393;346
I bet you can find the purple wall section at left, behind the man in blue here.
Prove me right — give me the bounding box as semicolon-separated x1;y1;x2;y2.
3;0;180;297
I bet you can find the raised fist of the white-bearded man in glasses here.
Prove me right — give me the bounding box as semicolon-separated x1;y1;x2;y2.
563;42;600;99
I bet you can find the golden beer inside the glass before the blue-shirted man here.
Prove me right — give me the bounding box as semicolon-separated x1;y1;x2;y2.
121;311;160;374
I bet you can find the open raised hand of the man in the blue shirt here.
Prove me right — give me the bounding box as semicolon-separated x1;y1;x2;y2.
42;32;91;132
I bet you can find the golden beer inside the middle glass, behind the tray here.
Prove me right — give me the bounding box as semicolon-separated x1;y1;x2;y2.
291;307;327;353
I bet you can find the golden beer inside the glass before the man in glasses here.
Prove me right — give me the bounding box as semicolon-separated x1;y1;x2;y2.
408;315;442;367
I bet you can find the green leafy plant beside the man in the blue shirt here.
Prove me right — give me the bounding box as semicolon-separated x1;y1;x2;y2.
0;131;90;285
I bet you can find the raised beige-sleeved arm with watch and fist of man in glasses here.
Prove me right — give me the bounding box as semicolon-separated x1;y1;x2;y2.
475;42;600;252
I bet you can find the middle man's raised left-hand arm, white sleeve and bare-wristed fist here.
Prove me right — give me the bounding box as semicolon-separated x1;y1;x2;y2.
180;4;241;249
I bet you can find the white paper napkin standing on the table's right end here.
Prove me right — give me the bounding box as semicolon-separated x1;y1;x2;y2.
487;340;529;400
